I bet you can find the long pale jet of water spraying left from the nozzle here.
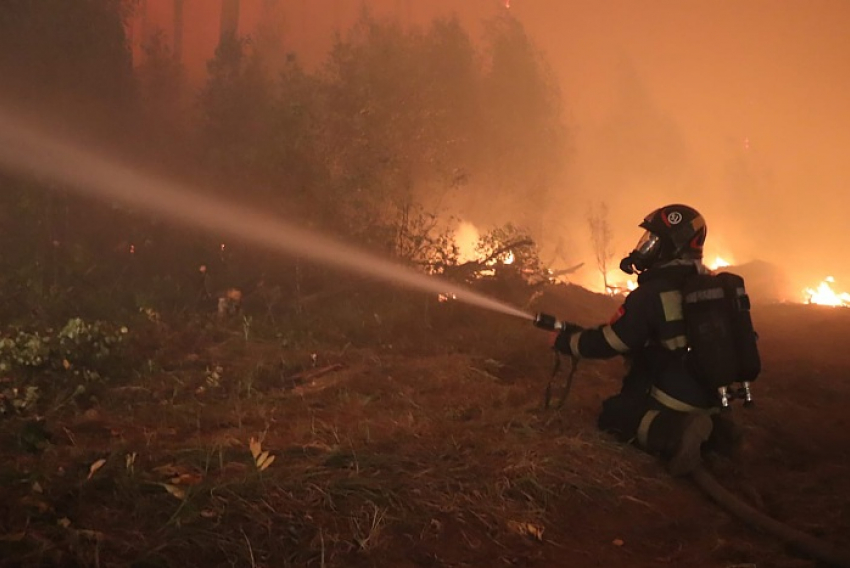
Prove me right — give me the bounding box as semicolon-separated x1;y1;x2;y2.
0;110;534;320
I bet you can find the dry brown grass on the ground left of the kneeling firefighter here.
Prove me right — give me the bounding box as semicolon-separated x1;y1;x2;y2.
0;292;846;567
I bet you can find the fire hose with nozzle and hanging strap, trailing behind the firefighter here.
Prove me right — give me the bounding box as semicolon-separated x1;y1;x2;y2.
534;314;850;568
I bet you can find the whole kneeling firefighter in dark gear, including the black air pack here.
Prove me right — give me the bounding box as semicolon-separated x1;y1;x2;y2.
555;205;760;476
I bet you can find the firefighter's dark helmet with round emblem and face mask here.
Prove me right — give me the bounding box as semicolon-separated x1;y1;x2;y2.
620;204;708;274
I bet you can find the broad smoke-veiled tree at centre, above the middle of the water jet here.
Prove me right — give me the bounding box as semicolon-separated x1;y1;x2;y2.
316;14;477;248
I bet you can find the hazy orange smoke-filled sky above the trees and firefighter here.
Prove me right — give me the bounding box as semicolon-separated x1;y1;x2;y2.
131;0;850;298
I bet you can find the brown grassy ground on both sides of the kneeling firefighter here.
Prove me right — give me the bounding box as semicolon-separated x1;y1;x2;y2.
0;284;850;568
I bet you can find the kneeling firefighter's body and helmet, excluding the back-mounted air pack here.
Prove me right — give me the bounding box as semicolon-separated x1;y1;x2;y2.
554;205;732;476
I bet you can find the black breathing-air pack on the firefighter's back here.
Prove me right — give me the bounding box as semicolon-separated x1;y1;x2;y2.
682;272;761;408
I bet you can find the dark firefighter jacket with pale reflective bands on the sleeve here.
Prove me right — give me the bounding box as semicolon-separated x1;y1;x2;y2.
559;260;716;412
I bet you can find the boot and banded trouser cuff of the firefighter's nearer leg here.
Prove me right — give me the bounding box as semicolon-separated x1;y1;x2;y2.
647;411;713;477
